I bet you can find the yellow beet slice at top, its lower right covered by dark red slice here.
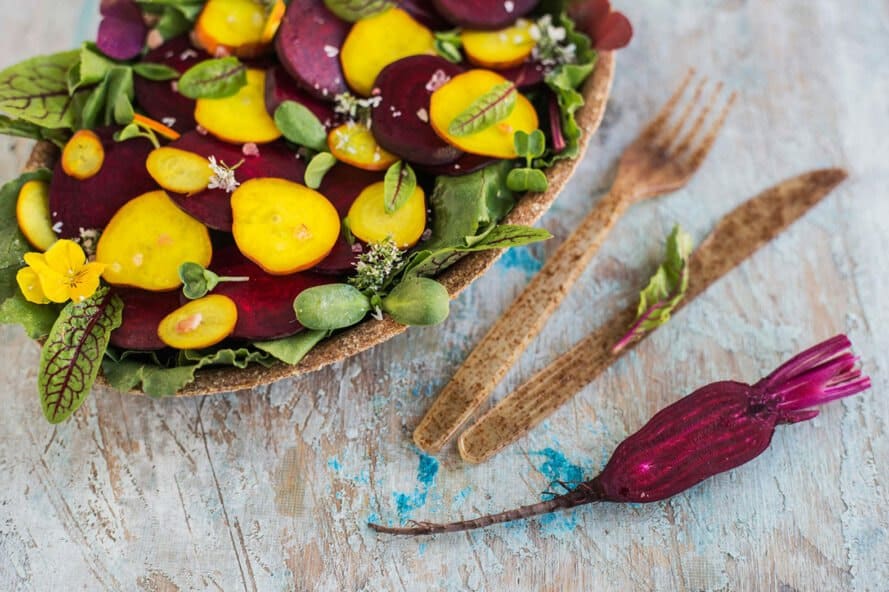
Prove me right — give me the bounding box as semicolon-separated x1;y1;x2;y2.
340;8;435;96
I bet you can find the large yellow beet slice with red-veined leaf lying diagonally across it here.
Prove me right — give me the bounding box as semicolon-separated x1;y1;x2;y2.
429;70;538;159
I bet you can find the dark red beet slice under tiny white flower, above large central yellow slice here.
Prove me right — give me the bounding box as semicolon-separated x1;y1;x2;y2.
167;131;306;232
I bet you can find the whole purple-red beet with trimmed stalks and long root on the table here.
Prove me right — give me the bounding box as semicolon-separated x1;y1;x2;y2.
370;335;870;534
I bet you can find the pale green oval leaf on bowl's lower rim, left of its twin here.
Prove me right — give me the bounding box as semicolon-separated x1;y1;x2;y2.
293;284;370;331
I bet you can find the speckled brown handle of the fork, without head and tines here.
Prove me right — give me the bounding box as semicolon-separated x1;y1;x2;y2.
414;186;631;452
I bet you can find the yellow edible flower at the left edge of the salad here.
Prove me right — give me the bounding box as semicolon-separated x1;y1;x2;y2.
17;240;105;302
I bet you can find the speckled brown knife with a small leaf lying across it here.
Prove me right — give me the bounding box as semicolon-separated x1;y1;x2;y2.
457;169;847;463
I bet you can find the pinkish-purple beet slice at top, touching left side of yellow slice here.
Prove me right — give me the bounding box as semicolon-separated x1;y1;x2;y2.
275;0;350;101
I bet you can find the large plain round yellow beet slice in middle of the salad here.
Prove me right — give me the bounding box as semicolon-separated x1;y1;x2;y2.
232;178;340;275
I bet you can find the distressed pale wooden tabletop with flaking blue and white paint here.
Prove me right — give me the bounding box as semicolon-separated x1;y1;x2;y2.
0;0;889;591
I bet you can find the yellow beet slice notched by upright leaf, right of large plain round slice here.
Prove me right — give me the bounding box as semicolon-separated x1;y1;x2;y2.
348;181;426;249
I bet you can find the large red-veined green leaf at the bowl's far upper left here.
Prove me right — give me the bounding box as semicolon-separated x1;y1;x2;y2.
0;50;87;129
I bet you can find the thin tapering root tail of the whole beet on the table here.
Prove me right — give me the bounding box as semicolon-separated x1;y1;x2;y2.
368;477;604;535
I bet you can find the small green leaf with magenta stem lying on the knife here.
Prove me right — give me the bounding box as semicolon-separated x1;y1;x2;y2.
612;224;693;353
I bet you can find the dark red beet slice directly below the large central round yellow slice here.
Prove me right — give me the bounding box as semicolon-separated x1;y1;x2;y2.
210;247;336;340
